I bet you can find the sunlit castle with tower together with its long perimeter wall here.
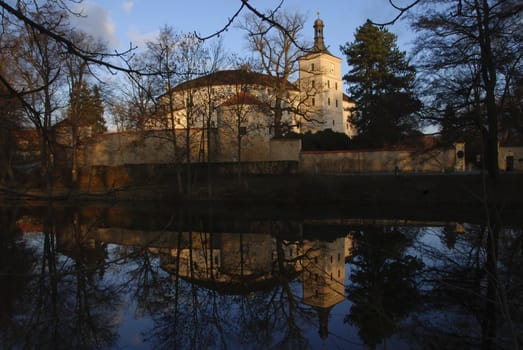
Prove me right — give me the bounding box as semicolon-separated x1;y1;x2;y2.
73;18;474;173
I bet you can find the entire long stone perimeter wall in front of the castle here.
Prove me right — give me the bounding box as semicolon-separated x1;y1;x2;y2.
79;129;462;174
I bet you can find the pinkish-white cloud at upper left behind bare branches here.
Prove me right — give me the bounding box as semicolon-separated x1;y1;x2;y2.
72;2;119;49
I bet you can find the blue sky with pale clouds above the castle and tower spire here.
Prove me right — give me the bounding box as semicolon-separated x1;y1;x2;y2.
73;0;418;74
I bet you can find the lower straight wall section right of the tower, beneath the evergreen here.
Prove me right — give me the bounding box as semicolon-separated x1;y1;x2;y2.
300;149;456;174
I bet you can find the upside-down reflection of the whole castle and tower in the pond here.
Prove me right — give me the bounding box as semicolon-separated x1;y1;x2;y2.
158;233;351;338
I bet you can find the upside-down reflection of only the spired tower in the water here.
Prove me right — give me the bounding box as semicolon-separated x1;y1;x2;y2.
302;237;346;339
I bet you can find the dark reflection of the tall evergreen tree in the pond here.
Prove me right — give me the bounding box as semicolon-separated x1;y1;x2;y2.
345;227;422;348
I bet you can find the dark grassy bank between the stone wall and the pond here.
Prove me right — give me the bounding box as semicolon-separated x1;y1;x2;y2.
2;173;523;207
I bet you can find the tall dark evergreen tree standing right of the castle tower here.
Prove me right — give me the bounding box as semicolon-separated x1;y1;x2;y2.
341;21;421;147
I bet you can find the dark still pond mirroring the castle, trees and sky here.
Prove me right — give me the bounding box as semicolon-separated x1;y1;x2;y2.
0;203;523;349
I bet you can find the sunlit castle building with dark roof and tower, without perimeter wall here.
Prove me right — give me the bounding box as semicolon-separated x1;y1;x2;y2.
141;14;355;161
